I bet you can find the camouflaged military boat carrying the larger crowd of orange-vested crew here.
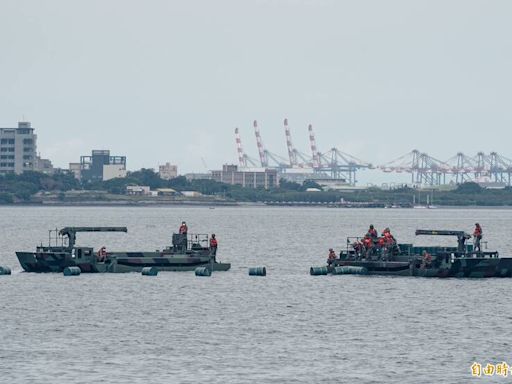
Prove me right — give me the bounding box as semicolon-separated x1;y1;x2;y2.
328;229;512;277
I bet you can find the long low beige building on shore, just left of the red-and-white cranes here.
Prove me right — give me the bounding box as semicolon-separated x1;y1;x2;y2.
212;164;279;189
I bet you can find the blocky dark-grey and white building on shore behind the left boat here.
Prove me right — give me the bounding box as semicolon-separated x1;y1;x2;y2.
69;150;126;182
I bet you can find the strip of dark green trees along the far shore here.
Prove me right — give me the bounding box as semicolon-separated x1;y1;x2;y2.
0;169;512;206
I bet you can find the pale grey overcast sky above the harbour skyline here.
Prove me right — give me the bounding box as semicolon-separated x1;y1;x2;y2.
0;0;512;182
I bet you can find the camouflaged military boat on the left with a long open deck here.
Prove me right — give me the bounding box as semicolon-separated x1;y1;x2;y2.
16;227;231;273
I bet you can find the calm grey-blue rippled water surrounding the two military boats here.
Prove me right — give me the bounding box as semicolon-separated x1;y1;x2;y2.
0;207;512;383
